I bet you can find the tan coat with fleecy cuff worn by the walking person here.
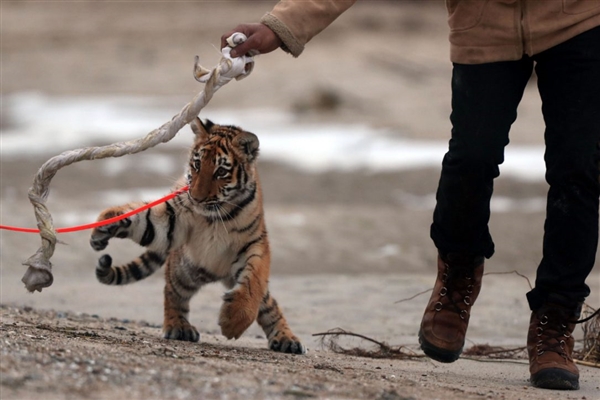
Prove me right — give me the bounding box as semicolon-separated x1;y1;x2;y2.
261;0;600;64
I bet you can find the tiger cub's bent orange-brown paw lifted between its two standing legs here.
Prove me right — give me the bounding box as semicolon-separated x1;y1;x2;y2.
219;291;258;339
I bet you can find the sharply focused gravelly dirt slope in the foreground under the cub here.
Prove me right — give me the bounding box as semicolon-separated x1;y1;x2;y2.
0;306;600;400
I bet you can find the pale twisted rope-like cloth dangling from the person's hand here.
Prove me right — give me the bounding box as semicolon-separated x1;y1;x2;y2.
21;33;254;292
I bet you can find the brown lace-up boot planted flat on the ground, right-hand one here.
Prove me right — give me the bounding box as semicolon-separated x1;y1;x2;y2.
527;304;579;390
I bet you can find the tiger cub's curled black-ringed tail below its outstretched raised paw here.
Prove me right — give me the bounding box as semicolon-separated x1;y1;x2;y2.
96;251;165;285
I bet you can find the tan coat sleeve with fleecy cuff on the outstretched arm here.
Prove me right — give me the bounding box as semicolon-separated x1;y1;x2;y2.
260;0;357;57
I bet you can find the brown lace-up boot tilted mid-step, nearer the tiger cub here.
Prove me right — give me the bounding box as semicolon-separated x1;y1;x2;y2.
419;254;484;363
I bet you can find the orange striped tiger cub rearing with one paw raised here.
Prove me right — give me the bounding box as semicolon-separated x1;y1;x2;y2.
90;118;306;354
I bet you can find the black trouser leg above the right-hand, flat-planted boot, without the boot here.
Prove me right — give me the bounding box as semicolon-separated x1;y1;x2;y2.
528;27;600;309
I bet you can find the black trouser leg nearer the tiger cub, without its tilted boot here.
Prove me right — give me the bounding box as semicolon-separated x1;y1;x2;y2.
431;58;533;258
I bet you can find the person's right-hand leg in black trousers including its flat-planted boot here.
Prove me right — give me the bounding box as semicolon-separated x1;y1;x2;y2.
527;27;600;389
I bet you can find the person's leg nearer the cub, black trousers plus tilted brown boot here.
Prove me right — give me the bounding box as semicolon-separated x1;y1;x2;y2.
419;58;533;362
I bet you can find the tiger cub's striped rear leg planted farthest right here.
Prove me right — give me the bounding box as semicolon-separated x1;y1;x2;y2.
256;291;306;354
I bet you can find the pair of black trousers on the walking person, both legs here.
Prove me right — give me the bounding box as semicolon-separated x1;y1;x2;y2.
431;27;600;310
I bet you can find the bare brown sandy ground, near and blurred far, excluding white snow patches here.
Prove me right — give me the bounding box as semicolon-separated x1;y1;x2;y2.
0;1;600;399
